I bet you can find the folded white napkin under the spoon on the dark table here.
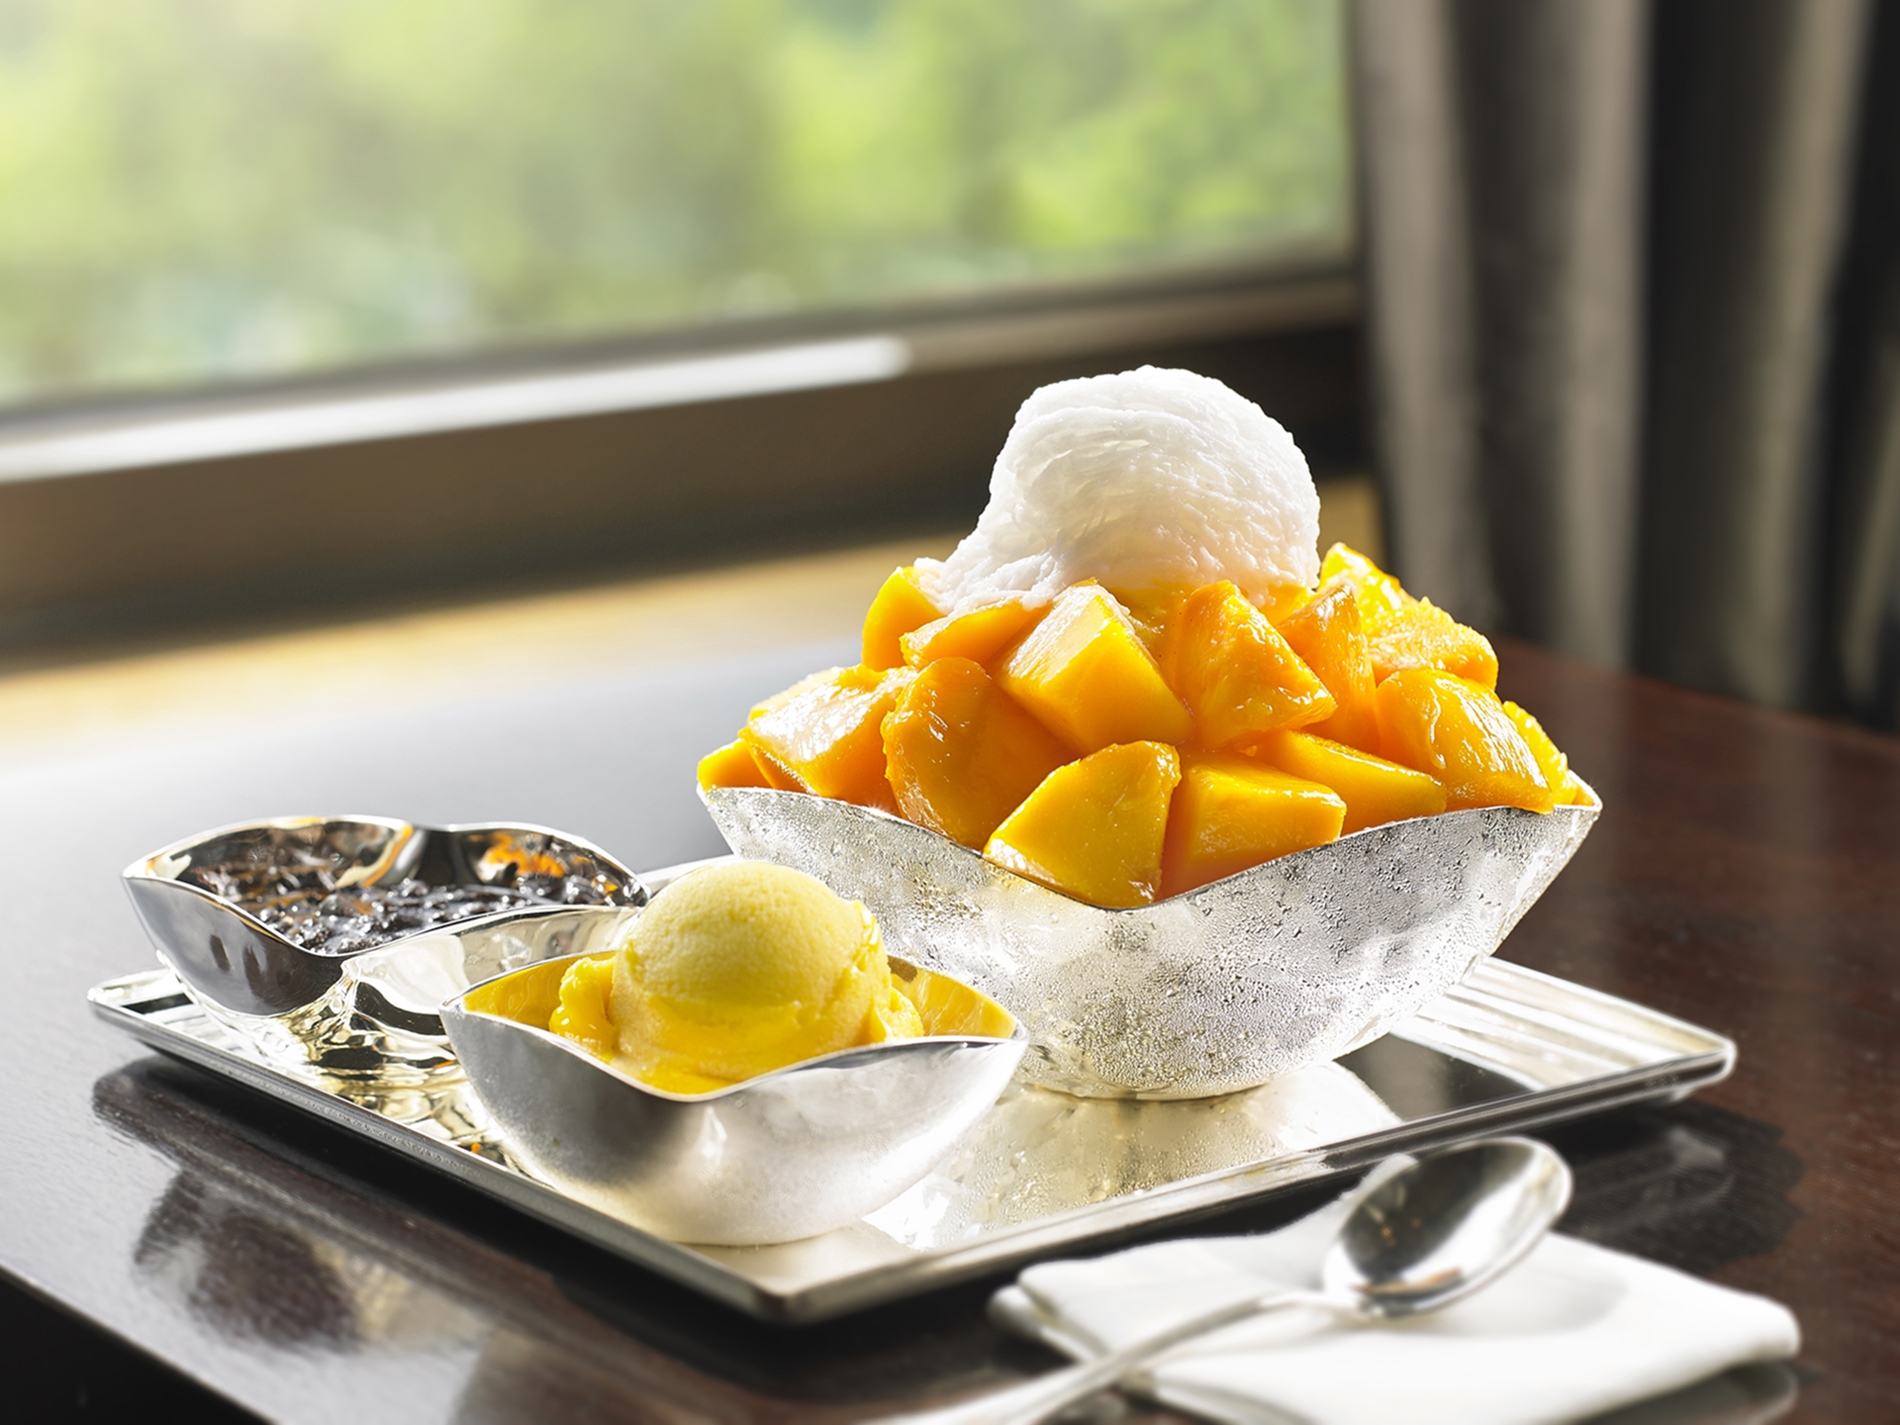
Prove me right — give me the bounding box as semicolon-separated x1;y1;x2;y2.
990;1203;1801;1425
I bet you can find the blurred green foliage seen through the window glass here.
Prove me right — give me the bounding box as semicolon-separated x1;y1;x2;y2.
0;0;1351;399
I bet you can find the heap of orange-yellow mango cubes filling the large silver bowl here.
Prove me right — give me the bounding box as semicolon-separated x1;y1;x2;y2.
699;545;1592;906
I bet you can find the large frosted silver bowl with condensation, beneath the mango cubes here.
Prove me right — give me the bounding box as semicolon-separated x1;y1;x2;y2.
701;787;1602;1098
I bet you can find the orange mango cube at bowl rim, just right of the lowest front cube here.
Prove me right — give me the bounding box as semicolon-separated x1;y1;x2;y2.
1161;752;1345;897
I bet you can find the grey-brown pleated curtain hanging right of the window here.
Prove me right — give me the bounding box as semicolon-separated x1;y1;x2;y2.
1351;0;1900;724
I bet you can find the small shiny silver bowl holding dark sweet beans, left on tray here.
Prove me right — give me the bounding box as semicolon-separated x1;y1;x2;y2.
124;815;648;1083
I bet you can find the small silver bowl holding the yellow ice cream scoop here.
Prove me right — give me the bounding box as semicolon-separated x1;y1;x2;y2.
441;950;1028;1246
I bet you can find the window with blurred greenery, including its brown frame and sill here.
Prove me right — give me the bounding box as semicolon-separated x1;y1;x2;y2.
0;0;1360;657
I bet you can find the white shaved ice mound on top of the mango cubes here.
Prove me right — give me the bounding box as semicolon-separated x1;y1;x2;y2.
918;367;1319;614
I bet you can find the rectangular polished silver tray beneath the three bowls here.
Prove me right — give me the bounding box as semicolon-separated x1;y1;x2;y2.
89;868;1735;1322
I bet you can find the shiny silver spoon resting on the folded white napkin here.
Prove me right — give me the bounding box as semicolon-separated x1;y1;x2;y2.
885;1138;1569;1425
